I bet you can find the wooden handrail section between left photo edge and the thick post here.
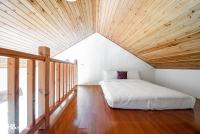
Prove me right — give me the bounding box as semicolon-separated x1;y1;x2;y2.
0;48;45;61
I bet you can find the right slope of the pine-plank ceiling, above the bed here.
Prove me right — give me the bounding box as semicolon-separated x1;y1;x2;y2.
97;0;200;69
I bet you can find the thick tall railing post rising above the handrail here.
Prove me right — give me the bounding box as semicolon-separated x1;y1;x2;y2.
38;46;50;129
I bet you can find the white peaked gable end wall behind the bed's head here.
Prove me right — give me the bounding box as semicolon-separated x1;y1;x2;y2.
55;33;154;84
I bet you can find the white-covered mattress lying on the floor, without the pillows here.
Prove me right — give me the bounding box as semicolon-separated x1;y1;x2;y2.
100;79;195;110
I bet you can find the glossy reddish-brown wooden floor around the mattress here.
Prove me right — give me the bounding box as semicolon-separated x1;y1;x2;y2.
41;86;200;134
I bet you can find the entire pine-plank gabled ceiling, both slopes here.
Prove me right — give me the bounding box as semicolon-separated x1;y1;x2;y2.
0;0;200;69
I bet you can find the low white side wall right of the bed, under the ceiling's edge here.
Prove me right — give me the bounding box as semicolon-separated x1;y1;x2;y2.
155;69;200;98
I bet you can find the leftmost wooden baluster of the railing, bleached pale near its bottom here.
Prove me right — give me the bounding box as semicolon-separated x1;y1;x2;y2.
7;58;19;134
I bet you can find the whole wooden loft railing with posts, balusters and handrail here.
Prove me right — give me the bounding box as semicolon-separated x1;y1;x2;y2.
0;47;77;134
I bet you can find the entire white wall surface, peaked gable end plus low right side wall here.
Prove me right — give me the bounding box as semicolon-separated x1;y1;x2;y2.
55;33;200;98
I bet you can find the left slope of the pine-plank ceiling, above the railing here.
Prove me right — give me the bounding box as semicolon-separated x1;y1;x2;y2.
0;0;96;56
